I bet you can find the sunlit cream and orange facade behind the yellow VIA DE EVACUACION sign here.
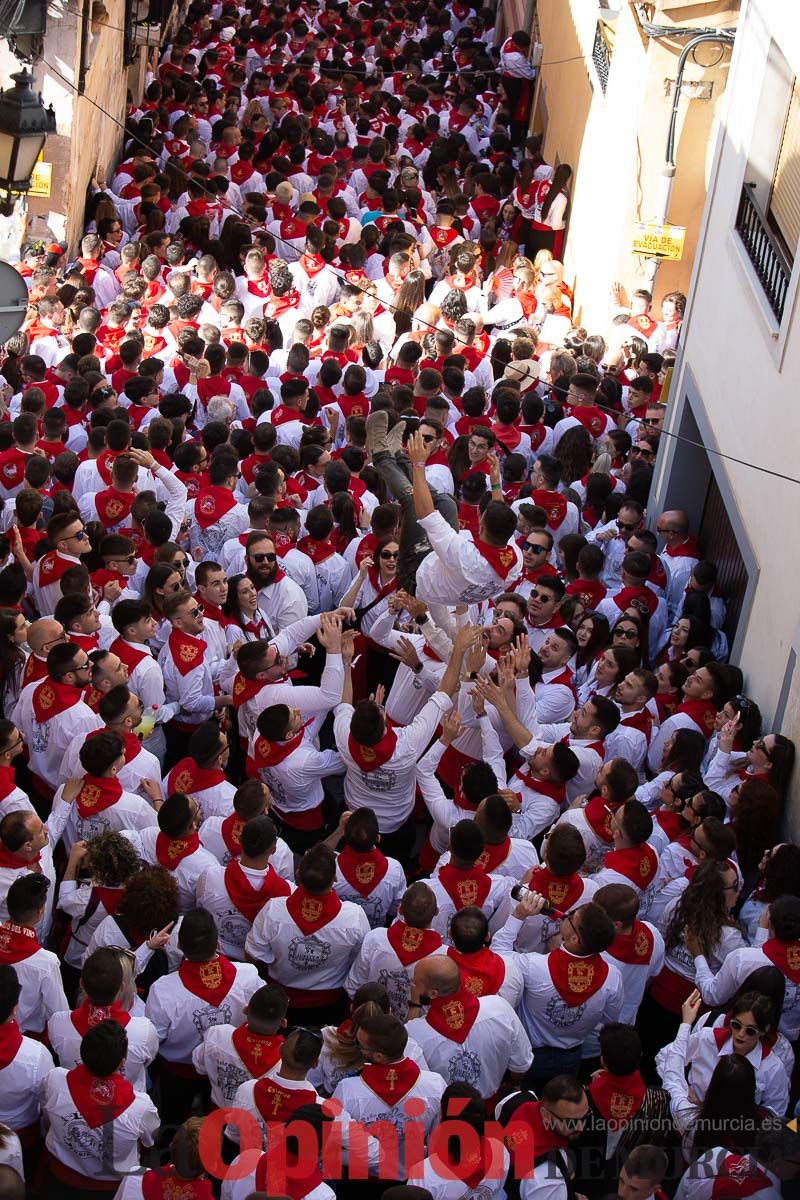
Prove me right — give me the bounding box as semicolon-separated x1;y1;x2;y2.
525;0;739;328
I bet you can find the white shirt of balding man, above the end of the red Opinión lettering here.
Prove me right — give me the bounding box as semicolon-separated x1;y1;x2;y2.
407;996;533;1099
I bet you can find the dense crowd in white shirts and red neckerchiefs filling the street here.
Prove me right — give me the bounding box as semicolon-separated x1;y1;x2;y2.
0;0;800;1200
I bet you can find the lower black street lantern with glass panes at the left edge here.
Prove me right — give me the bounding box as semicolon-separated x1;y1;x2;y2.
0;70;55;216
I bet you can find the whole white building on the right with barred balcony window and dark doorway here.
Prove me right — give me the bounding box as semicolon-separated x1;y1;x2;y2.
651;0;800;836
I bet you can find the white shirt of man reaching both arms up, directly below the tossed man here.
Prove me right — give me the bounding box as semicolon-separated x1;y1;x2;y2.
333;691;452;833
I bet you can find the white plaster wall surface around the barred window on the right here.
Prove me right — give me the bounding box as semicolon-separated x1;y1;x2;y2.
658;0;800;824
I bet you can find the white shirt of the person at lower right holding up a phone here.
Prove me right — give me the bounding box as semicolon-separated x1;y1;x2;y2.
494;917;625;1050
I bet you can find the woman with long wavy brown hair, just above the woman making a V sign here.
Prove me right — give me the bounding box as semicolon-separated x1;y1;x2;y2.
637;859;745;1052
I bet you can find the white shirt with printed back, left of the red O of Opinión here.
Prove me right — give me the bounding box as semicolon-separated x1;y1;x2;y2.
42;1067;160;1181
